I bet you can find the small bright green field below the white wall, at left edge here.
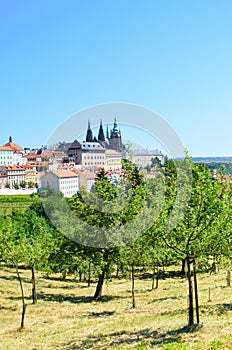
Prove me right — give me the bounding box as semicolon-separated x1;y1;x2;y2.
0;195;33;215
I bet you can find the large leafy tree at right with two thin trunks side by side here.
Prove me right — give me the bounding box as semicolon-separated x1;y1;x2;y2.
162;164;228;326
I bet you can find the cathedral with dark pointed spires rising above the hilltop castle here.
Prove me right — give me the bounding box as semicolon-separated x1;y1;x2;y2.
86;117;125;152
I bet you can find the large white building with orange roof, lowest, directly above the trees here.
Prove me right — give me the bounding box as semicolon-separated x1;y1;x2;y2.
40;170;79;197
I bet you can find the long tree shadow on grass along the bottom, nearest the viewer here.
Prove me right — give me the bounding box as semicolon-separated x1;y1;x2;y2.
63;325;200;350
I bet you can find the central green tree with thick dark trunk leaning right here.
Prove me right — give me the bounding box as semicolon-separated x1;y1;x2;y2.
69;163;147;300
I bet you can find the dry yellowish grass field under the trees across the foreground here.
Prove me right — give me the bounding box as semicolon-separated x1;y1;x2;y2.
0;267;232;350
